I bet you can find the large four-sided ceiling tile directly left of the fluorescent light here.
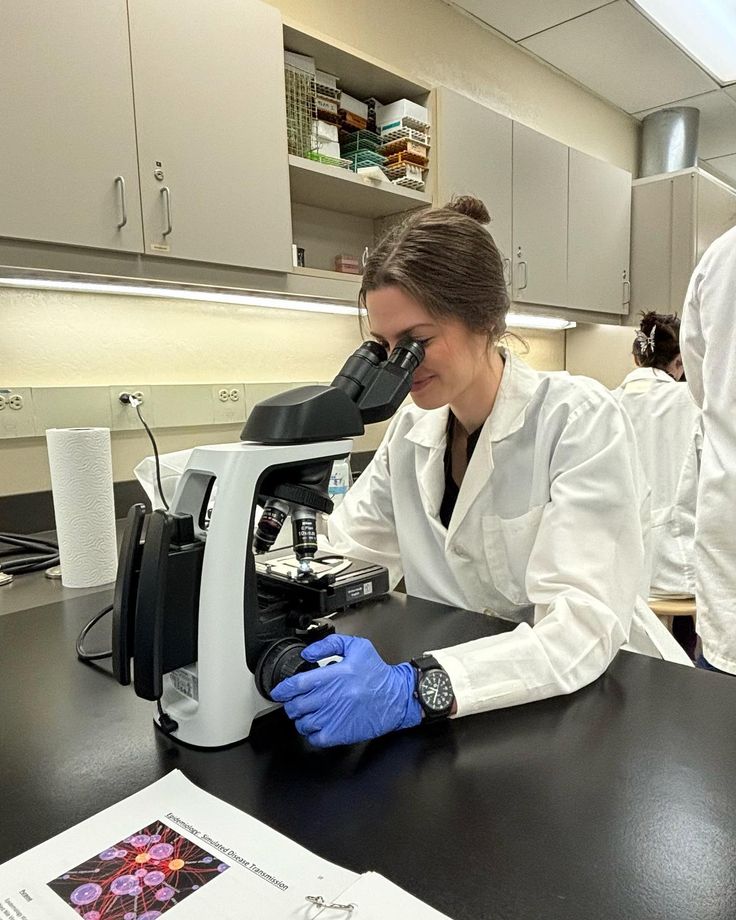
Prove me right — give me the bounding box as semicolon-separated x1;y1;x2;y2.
521;0;718;112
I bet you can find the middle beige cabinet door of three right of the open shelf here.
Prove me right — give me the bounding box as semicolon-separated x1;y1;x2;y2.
513;122;568;306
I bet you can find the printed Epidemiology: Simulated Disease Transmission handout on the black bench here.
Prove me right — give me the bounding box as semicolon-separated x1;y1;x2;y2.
0;770;454;920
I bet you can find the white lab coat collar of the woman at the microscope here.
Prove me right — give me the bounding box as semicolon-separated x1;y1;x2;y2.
406;348;542;456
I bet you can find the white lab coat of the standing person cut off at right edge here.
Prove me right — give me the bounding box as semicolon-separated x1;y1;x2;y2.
680;220;736;674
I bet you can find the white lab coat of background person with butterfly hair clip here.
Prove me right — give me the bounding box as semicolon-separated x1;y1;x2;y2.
613;367;700;596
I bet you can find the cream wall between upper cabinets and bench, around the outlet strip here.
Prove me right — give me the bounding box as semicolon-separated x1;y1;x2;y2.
0;289;564;495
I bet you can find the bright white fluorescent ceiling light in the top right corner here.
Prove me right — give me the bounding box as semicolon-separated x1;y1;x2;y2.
635;0;736;83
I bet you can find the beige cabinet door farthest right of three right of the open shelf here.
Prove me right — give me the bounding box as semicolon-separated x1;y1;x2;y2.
567;149;631;313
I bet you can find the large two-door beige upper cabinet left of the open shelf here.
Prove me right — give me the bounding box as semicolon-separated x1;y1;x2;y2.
0;0;291;271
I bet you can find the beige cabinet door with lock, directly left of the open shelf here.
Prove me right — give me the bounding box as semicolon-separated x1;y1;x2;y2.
129;0;291;271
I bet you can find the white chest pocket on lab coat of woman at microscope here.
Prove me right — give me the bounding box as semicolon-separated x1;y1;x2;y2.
483;505;545;604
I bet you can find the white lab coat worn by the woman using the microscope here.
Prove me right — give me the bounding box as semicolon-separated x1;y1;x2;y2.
328;352;689;716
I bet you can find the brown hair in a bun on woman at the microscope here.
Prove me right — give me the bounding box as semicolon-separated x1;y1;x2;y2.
359;196;509;343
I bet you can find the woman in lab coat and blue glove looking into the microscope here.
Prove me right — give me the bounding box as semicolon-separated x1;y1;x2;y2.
272;198;687;747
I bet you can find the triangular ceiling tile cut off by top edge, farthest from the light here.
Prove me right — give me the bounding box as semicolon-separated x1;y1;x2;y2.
456;0;610;41
